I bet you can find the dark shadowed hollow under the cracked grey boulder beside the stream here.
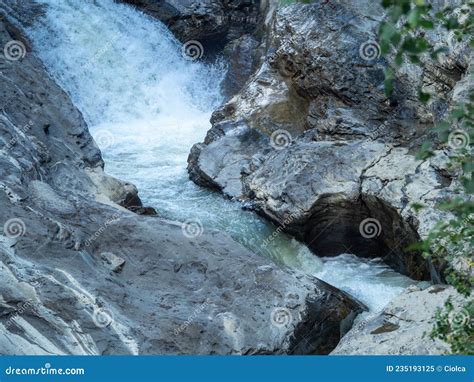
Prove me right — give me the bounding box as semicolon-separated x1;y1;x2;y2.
299;195;440;280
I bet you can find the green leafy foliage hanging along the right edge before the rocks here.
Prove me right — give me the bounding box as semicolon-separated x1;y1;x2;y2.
379;0;474;354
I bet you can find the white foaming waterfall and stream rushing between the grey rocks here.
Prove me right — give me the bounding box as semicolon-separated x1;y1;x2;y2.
28;0;426;312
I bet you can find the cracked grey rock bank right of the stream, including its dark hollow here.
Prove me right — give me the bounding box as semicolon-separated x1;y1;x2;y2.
188;0;472;354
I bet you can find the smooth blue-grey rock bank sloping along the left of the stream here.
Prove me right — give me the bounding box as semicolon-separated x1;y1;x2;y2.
0;1;364;354
